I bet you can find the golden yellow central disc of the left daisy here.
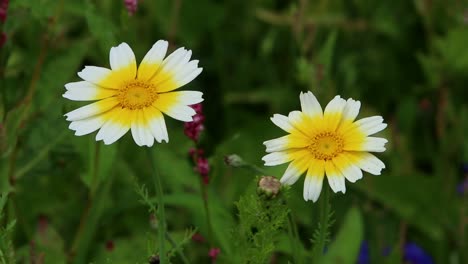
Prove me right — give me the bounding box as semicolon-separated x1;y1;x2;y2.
117;80;158;110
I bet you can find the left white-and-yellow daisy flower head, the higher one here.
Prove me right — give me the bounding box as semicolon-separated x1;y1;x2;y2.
63;40;203;147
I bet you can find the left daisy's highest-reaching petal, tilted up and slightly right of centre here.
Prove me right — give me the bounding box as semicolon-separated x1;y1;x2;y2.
138;40;169;80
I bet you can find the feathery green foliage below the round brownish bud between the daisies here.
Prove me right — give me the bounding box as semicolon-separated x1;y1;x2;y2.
232;184;289;263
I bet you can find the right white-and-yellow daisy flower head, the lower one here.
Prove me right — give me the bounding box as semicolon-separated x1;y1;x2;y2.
262;92;387;202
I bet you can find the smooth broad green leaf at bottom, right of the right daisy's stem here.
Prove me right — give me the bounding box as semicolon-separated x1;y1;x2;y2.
320;207;364;264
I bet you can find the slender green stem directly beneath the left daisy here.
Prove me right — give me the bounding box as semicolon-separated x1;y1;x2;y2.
146;148;168;264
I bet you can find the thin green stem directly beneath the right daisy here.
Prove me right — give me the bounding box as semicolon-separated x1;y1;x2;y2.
312;187;331;263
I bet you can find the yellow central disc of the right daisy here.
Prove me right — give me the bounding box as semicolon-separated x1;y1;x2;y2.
308;132;344;160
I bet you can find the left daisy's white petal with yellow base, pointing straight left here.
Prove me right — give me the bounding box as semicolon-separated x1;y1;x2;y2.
63;81;116;101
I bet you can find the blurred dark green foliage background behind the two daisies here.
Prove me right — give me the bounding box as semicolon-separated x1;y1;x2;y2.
0;0;468;264
